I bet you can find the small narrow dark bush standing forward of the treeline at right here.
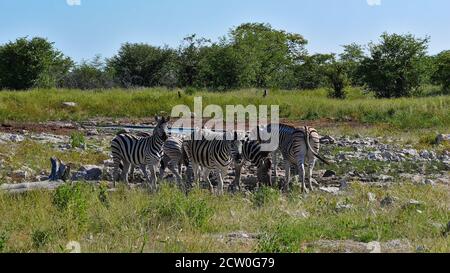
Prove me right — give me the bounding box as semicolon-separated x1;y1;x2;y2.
324;61;348;99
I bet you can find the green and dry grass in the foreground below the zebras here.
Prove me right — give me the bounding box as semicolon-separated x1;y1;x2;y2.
0;183;450;252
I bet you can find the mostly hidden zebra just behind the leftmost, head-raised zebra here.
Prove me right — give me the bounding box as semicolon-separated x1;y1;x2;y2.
159;136;189;186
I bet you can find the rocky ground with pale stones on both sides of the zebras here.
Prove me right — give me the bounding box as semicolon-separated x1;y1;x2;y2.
0;122;450;193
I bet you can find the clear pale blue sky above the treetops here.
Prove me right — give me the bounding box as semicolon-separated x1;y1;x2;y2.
0;0;450;61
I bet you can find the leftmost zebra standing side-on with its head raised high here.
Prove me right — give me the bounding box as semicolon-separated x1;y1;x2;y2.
111;117;170;189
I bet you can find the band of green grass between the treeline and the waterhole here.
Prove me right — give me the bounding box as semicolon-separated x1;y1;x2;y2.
0;88;450;129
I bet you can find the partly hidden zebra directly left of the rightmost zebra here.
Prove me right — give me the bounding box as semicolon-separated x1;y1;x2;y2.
230;126;272;191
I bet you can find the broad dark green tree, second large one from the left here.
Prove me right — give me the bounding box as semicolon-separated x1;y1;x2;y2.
108;43;174;87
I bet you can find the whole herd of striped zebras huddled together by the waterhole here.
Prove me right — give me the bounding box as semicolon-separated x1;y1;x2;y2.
111;117;328;195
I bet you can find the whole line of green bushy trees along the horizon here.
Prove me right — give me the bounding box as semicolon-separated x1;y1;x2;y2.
0;23;450;98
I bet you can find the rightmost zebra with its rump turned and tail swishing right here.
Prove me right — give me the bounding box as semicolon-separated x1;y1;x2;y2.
267;124;329;192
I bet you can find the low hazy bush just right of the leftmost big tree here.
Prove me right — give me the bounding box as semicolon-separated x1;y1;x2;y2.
61;56;114;89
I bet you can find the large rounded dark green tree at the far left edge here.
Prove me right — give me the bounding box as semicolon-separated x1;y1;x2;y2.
0;37;73;90
